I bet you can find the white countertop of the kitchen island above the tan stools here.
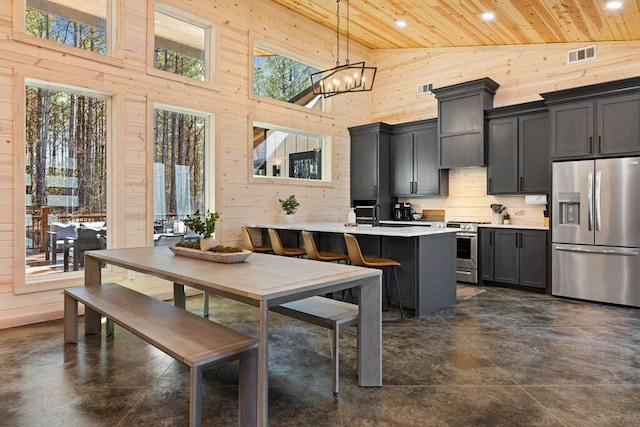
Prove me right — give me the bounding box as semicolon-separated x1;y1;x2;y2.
247;222;457;237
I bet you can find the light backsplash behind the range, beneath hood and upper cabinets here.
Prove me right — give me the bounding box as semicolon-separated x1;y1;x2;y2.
400;168;546;226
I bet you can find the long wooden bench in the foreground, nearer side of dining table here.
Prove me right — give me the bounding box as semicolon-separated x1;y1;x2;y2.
64;283;258;426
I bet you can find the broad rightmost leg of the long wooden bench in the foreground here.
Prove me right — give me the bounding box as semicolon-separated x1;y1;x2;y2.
238;348;258;426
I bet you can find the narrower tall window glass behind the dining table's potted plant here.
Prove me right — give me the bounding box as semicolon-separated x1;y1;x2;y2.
153;108;207;225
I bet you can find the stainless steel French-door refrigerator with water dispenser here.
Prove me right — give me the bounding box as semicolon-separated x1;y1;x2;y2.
551;157;640;307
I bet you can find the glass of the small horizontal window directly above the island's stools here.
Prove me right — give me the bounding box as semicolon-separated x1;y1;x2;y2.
253;125;326;180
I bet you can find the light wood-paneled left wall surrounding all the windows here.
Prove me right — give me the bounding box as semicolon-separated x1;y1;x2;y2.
0;0;371;328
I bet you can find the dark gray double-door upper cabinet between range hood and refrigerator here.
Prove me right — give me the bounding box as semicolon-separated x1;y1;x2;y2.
487;101;551;194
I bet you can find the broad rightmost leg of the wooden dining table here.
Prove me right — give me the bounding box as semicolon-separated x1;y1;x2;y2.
358;273;382;387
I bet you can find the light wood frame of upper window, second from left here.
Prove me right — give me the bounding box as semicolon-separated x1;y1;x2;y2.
147;0;220;89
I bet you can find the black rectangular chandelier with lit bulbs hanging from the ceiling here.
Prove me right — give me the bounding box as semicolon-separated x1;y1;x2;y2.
311;0;377;98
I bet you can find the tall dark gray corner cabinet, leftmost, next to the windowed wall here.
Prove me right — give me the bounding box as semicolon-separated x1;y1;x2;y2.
349;123;392;219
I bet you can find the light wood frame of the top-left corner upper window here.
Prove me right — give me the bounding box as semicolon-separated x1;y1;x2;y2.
12;0;124;68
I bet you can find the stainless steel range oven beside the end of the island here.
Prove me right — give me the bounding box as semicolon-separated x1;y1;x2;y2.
446;221;478;283
